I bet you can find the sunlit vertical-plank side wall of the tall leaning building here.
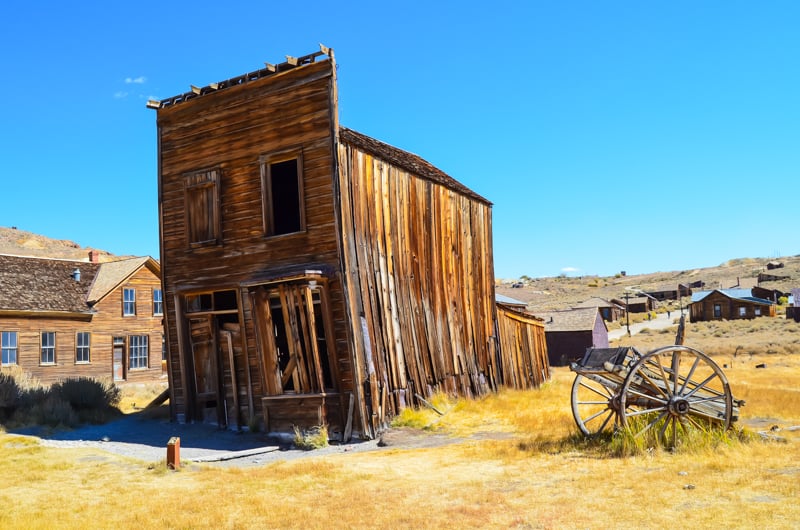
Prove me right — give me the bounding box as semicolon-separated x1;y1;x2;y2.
339;141;498;432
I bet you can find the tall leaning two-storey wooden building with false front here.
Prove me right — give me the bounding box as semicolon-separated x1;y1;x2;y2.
148;47;543;439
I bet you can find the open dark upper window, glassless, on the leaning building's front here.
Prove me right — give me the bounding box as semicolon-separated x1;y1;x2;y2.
260;150;305;236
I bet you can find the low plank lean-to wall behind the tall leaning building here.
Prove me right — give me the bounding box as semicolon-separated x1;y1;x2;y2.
497;305;550;389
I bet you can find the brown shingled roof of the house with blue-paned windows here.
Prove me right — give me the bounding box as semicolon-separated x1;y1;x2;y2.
0;254;159;314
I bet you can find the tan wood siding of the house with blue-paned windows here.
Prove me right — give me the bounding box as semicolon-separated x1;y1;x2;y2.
0;267;166;385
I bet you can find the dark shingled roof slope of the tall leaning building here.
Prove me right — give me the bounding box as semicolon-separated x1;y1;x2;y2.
339;127;492;205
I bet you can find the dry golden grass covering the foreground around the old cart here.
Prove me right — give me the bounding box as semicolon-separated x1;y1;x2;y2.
0;354;800;529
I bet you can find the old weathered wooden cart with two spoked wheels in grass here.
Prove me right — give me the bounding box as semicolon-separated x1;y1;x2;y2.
570;345;744;447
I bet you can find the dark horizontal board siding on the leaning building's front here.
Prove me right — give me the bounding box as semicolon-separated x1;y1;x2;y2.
158;60;353;419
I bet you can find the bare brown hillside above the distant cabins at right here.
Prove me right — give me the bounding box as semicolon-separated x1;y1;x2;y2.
497;256;800;310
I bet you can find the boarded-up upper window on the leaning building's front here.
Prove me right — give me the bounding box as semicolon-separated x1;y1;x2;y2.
184;169;220;247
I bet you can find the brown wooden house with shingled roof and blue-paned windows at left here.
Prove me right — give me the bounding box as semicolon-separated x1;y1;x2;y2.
0;252;166;384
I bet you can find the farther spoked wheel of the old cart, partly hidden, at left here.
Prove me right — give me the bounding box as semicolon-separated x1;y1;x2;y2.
572;374;619;436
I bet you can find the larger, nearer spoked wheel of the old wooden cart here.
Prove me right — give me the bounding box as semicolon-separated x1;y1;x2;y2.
620;346;733;447
